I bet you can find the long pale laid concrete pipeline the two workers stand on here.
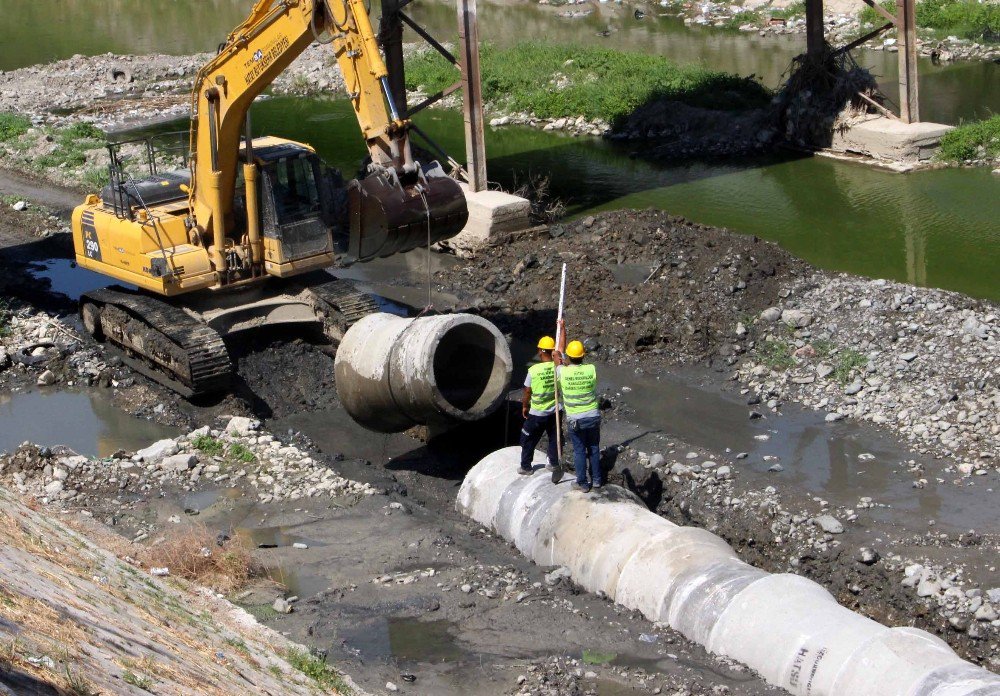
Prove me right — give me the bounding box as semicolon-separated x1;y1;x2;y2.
457;447;1000;696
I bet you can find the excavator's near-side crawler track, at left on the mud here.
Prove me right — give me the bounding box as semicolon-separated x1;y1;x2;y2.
80;286;232;398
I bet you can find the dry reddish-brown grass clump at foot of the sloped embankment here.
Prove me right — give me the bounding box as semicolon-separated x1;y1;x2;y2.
142;526;261;593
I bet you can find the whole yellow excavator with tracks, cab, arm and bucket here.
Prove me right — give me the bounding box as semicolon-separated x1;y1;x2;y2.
73;0;468;396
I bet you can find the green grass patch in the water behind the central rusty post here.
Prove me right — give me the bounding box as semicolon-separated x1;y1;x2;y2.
406;43;771;124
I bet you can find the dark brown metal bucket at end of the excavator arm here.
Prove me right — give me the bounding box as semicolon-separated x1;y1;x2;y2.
348;162;469;261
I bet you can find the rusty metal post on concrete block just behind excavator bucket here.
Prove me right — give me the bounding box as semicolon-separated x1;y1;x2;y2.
458;0;486;191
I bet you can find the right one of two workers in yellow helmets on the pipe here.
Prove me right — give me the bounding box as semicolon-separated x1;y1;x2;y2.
557;341;604;493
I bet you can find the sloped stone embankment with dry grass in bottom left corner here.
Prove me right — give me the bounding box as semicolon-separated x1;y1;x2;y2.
0;487;362;696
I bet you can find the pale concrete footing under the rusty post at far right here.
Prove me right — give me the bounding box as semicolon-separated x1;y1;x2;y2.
830;116;953;164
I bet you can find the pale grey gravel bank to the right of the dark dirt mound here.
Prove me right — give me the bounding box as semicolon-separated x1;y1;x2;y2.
739;274;1000;476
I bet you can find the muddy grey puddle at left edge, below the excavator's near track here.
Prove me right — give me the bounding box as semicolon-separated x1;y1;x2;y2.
0;391;180;457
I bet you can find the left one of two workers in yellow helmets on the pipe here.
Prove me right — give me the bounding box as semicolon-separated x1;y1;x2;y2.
520;336;562;481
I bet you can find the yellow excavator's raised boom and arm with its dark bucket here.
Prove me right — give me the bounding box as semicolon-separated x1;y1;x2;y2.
188;0;465;275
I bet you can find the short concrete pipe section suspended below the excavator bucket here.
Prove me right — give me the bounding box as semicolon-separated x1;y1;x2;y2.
334;314;512;433
